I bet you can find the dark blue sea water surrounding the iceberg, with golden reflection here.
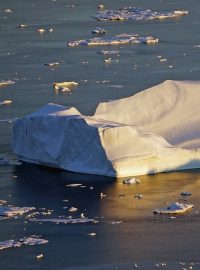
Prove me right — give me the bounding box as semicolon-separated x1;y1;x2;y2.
0;0;200;270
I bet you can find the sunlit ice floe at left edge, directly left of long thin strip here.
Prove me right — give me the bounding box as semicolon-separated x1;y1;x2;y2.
0;206;35;217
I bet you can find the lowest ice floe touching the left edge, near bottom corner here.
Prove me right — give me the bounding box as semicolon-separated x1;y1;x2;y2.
0;235;48;250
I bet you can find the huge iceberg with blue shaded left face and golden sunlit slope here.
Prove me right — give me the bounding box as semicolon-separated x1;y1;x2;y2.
12;80;200;177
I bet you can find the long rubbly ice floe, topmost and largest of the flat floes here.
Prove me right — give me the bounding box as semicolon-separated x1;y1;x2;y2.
94;7;188;21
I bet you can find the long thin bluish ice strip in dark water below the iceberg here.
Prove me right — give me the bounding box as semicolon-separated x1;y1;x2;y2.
29;218;97;224
